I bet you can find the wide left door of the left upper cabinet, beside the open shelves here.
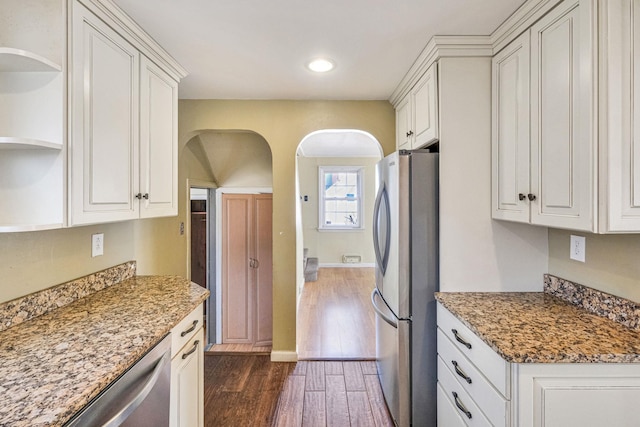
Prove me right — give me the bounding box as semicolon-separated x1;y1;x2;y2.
70;2;140;225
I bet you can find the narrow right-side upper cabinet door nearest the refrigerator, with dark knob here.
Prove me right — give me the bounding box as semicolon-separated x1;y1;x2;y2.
492;31;530;222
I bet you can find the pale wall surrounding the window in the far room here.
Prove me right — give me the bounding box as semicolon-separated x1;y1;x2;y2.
298;157;379;264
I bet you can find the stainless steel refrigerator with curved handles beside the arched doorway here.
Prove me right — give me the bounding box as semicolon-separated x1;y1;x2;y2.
371;150;438;427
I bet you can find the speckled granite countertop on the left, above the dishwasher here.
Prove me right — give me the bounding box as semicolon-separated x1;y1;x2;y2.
0;276;209;427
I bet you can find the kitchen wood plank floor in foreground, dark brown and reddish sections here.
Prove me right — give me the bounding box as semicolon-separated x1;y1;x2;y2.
204;353;393;427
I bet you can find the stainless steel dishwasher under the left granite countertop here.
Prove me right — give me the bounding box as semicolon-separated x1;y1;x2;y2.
65;334;171;427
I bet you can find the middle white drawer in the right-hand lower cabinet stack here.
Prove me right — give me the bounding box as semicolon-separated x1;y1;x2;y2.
438;330;508;425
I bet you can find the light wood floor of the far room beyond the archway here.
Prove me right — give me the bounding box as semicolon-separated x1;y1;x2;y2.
297;268;375;360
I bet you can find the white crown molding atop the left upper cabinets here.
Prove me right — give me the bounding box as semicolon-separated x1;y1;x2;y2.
78;0;188;81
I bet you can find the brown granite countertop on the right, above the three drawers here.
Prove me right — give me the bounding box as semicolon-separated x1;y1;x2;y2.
436;292;640;363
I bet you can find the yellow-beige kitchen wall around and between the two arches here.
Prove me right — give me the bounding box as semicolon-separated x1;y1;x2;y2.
175;100;395;353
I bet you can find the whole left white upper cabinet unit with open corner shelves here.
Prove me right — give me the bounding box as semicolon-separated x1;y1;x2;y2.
0;0;186;232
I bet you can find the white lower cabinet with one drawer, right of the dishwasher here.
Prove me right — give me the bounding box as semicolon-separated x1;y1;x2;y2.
170;307;204;427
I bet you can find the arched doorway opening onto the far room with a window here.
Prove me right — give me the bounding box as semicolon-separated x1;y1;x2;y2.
297;129;382;360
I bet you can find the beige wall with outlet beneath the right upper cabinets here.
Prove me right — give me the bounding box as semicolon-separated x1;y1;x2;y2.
549;230;640;303
